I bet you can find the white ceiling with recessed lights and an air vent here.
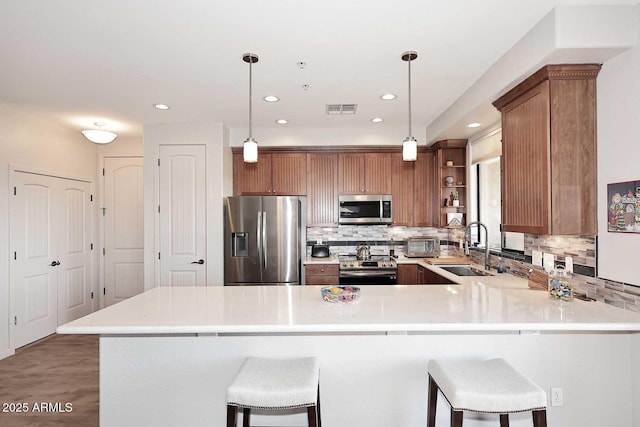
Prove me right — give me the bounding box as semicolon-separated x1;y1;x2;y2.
0;0;637;142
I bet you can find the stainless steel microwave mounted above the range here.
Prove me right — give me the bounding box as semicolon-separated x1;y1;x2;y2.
338;194;393;224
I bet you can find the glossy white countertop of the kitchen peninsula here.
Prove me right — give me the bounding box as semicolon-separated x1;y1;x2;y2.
57;270;640;335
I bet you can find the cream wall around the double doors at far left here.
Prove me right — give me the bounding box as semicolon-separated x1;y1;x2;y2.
0;104;97;358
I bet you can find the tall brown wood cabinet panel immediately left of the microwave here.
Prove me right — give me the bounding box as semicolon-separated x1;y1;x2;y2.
307;153;338;226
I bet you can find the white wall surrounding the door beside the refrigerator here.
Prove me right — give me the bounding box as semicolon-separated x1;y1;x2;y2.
144;123;231;290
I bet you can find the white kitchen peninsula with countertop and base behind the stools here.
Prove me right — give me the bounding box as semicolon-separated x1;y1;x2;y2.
58;266;640;427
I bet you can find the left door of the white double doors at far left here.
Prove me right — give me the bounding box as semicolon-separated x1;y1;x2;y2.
10;172;59;348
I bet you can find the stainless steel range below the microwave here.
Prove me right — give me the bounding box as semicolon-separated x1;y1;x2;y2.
338;255;398;285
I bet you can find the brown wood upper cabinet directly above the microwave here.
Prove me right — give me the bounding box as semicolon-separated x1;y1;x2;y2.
338;153;391;194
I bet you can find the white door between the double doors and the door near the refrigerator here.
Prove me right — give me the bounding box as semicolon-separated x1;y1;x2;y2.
103;157;144;307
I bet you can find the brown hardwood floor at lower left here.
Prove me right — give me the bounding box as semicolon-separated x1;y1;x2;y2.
0;335;99;427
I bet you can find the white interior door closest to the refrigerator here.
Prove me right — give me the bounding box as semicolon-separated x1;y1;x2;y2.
158;145;207;286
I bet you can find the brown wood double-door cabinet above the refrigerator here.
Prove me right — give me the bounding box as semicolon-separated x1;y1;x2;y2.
233;153;307;196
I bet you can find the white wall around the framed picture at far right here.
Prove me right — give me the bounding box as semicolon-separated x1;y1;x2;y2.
597;5;640;286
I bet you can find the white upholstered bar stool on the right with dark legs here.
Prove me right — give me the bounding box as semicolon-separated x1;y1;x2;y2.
427;359;547;427
